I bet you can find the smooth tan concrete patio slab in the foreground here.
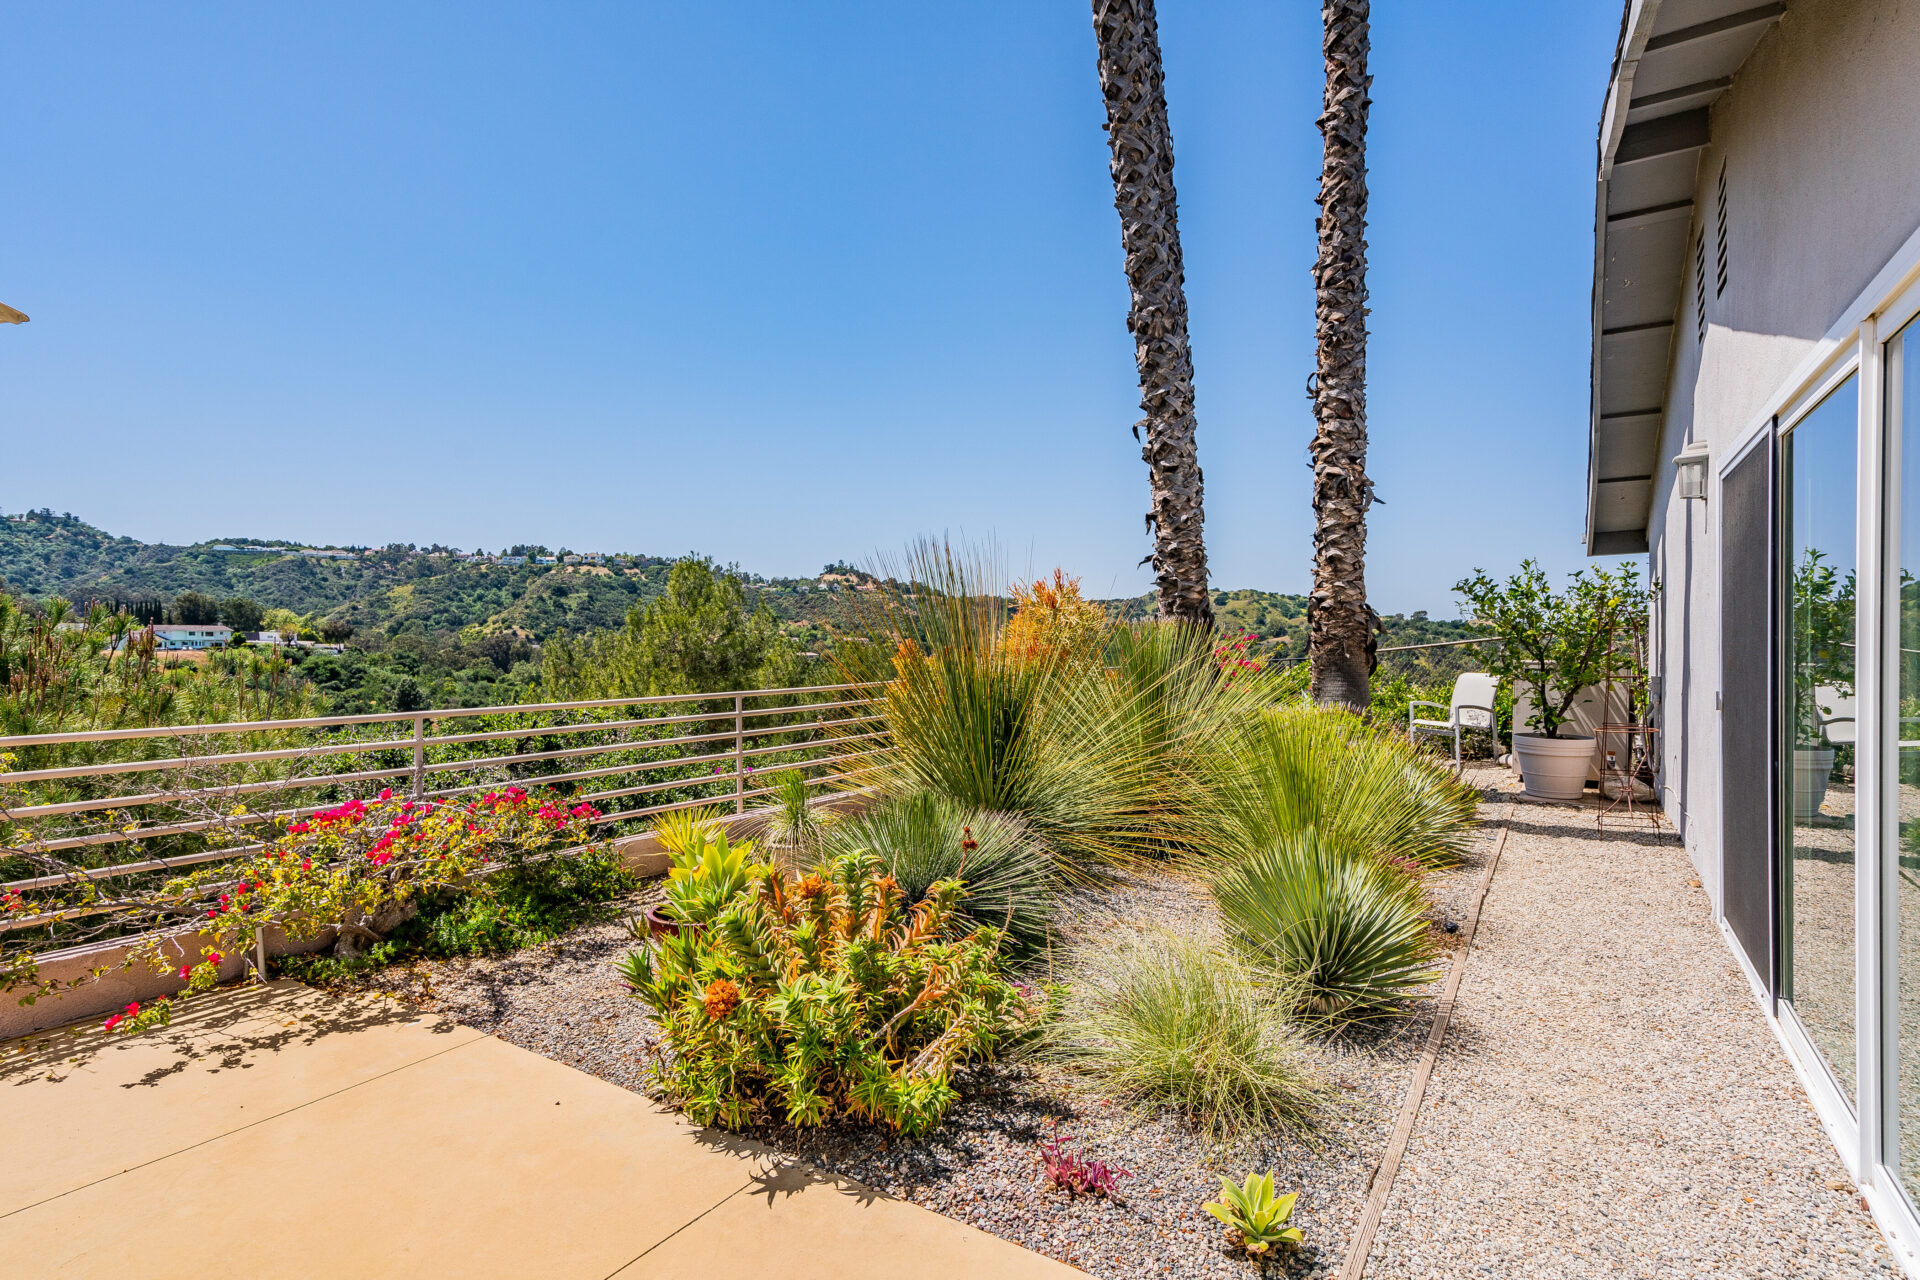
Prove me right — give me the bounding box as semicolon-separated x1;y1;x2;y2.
0;984;1079;1280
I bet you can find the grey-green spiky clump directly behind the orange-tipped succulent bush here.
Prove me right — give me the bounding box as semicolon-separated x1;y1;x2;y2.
822;791;1056;958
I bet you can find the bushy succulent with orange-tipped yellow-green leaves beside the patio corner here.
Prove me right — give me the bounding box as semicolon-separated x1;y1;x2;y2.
620;852;1044;1134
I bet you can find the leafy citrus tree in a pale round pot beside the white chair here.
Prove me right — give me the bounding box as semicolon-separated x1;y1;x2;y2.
1453;560;1647;800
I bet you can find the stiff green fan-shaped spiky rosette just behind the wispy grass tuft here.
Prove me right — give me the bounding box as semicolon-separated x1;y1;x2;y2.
1213;829;1434;1021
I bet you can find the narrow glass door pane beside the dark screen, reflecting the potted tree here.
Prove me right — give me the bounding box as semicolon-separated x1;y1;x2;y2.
1780;378;1859;1103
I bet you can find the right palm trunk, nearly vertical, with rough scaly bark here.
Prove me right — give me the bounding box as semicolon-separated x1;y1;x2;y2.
1308;0;1375;710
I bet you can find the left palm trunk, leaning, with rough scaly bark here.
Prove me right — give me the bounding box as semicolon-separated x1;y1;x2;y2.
1092;0;1213;626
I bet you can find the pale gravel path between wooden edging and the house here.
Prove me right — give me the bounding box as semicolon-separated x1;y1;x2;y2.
1367;773;1899;1280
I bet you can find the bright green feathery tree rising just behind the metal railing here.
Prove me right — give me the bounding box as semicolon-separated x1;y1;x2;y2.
541;557;803;699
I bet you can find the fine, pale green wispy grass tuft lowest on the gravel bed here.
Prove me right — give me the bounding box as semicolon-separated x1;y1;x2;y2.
1044;933;1331;1136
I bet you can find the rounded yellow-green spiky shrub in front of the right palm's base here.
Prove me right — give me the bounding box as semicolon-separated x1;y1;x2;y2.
1210;706;1478;865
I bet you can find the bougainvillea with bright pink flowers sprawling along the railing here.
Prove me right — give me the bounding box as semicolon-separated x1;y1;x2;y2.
4;787;599;1032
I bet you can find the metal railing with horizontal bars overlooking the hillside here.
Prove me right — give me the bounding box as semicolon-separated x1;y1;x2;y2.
0;683;887;933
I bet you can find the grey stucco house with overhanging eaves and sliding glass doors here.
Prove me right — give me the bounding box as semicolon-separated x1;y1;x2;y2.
1586;0;1920;1274
